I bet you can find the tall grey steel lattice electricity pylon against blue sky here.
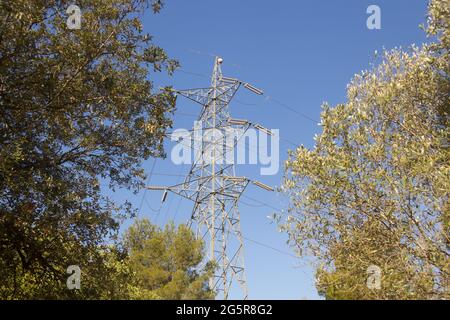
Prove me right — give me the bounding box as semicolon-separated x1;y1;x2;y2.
147;57;273;299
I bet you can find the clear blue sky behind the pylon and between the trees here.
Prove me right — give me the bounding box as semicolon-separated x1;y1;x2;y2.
109;0;427;299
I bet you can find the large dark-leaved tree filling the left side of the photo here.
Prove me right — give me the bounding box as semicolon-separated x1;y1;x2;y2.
0;0;177;298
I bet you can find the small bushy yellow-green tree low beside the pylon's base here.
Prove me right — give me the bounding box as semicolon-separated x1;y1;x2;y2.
124;219;215;299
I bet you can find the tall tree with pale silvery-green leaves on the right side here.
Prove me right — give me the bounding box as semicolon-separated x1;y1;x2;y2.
278;0;450;299
